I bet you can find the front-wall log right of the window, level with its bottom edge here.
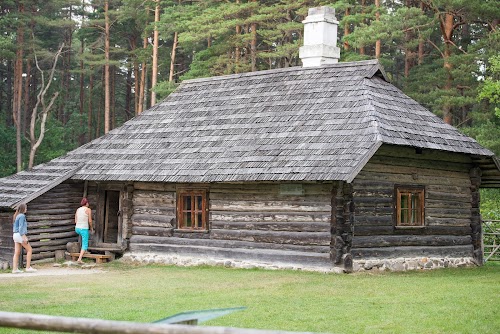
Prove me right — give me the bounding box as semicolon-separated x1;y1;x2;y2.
210;221;330;232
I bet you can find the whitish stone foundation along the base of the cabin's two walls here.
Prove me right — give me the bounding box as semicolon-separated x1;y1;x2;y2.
120;253;476;273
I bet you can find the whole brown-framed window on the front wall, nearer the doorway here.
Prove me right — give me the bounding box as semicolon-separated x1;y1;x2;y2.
177;190;208;231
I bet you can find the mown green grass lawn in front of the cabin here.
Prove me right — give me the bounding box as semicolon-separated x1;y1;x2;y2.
0;262;500;333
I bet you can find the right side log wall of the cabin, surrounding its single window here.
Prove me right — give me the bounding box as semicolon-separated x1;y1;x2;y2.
351;146;477;259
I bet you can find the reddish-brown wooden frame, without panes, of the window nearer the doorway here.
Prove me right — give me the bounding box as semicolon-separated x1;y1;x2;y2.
177;189;208;232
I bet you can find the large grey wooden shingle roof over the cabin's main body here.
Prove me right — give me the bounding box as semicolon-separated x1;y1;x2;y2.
0;60;493;207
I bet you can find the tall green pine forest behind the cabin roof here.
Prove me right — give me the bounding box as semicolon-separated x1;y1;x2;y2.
0;0;500;202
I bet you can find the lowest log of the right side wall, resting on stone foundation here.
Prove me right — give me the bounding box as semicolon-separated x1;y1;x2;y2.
351;245;473;259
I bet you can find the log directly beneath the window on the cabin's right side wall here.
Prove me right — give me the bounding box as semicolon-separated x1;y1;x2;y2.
354;225;472;236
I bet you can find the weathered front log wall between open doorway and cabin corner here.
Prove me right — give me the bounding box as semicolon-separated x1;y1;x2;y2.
130;183;333;261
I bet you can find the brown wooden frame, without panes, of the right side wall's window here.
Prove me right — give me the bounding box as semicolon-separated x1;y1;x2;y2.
394;185;425;228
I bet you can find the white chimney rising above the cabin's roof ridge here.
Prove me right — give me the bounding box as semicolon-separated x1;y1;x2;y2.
299;6;340;67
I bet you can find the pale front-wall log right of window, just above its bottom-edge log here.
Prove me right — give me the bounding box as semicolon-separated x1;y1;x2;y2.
210;210;331;222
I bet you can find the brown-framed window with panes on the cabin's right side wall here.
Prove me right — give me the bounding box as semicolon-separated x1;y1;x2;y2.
395;186;425;227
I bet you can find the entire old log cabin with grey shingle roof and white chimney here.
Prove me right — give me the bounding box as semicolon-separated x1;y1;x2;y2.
0;7;500;272
